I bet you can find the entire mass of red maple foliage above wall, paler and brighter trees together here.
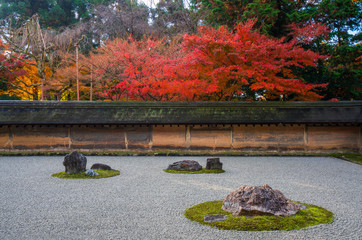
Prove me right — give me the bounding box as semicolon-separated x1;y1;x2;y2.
85;21;324;101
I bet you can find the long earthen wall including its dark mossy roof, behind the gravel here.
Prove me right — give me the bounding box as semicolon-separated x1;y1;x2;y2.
0;101;362;153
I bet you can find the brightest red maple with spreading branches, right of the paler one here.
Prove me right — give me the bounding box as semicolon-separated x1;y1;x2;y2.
183;21;325;100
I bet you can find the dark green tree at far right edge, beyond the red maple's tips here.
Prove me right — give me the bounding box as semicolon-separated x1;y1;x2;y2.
304;0;362;100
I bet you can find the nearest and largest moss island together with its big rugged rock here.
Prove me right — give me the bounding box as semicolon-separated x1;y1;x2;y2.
185;185;334;231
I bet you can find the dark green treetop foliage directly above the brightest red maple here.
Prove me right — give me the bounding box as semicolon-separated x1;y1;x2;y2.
193;0;313;37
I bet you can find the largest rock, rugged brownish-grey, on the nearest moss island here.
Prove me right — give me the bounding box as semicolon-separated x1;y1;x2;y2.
222;184;300;216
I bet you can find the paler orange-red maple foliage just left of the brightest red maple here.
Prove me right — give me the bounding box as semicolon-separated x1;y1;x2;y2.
92;37;216;101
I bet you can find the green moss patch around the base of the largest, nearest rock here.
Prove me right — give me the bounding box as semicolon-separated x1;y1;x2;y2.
185;201;334;231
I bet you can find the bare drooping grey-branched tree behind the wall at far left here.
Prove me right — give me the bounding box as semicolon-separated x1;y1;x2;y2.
1;15;87;100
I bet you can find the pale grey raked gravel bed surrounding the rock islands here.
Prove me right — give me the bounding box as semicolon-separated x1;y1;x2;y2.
0;156;362;240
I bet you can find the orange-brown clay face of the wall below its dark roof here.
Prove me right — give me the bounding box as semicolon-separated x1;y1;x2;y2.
0;124;362;152
